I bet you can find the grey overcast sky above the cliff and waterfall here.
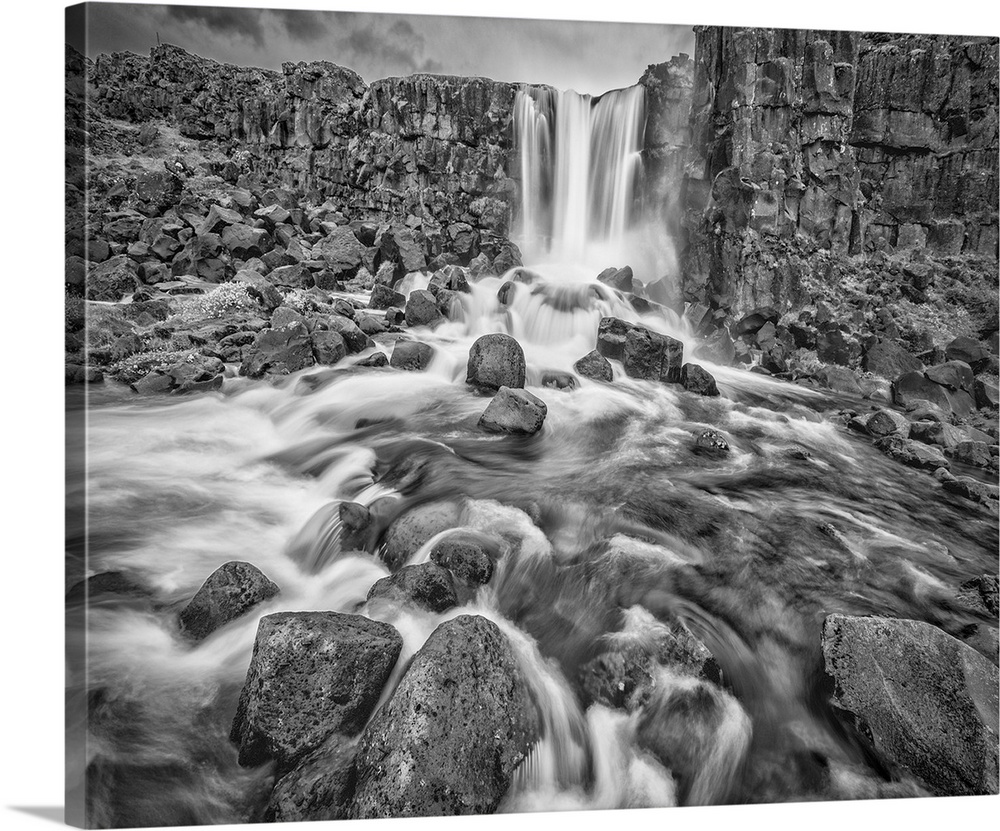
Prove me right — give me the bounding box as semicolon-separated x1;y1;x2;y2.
74;3;694;95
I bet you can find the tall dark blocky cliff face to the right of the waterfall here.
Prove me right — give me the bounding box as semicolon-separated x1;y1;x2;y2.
683;27;998;316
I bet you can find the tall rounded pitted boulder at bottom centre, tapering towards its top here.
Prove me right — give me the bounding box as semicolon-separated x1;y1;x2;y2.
353;615;538;818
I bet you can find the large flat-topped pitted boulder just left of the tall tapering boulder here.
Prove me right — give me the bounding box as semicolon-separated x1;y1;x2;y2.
230;612;403;771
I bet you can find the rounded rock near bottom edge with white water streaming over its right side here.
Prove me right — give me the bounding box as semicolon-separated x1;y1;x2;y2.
636;674;752;805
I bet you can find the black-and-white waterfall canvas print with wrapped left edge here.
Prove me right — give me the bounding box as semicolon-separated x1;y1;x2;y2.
65;4;1000;828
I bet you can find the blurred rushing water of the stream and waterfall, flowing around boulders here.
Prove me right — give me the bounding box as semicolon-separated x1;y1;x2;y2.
69;84;998;825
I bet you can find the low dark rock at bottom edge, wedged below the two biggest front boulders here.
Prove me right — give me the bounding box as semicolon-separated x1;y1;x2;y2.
263;736;357;822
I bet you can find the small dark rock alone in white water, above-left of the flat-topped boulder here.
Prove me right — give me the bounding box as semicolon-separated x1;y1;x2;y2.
180;560;280;641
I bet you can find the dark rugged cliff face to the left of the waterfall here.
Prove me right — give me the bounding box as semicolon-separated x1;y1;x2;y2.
90;45;516;238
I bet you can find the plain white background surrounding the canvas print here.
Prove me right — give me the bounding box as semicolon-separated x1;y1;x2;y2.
0;0;1000;831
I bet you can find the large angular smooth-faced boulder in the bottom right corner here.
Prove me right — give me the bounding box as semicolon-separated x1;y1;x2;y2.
823;615;1000;796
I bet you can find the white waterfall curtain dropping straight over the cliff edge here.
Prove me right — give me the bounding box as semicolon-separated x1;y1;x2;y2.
514;85;646;269
